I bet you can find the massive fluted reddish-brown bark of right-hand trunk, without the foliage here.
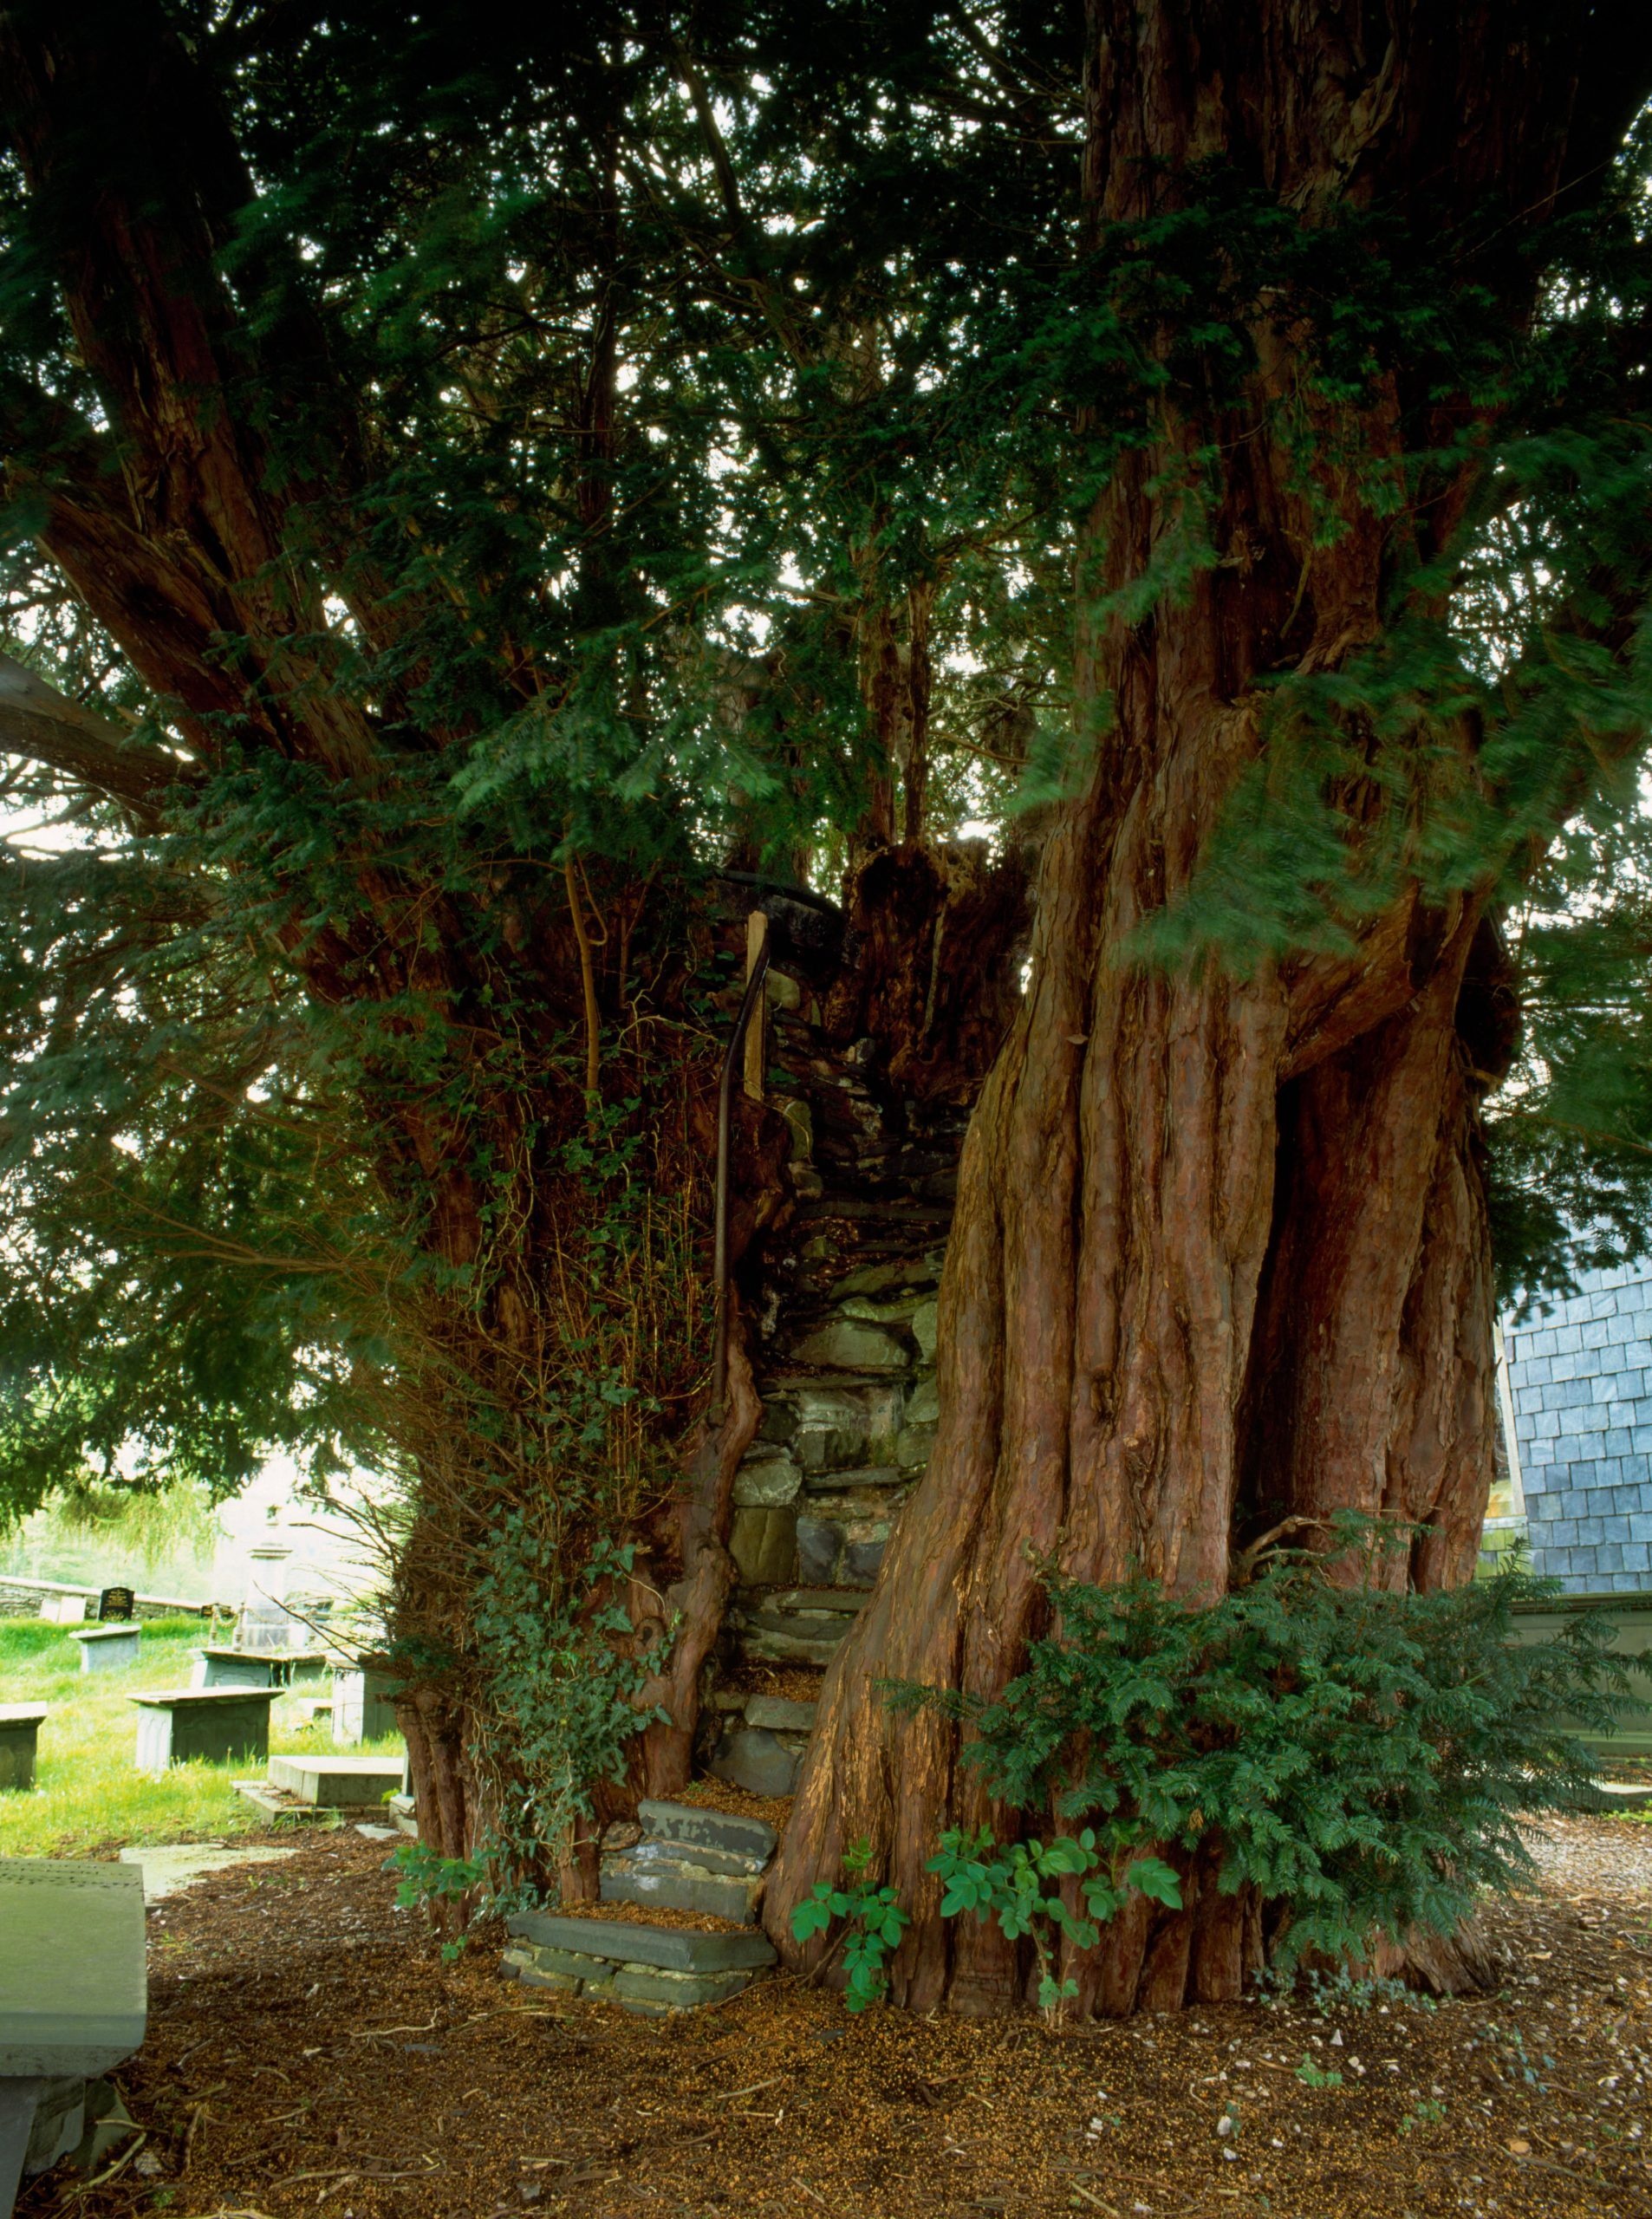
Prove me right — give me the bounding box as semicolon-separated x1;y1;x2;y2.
767;0;1641;2013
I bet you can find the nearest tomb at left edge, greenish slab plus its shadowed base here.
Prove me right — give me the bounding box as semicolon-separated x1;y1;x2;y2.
0;1858;146;2219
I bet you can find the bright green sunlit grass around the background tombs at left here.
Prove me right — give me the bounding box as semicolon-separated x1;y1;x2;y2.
0;1617;401;1858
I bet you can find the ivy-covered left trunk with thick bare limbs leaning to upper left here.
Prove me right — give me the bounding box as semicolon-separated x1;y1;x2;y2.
0;7;767;1893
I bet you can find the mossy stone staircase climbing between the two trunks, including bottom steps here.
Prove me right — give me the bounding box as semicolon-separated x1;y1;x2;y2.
505;940;965;2014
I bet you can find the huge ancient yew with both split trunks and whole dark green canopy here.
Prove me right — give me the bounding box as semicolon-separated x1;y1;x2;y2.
0;0;1652;2010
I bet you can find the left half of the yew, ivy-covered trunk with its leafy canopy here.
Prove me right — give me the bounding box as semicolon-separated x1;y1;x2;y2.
0;4;1073;1886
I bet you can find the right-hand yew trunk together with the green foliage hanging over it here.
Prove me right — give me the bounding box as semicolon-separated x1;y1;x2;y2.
765;0;1652;2013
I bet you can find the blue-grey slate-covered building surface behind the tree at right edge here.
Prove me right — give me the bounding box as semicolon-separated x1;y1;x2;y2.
1504;1263;1652;1596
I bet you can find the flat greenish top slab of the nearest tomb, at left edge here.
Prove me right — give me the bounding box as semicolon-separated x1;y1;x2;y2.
0;1858;148;2079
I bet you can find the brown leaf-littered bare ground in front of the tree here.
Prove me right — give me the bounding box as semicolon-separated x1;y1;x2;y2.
17;1819;1652;2219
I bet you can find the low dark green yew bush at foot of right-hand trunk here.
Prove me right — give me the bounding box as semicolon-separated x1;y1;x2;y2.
889;1536;1643;1966
